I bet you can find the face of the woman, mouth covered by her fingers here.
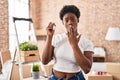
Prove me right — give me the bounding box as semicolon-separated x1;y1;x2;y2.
63;13;79;33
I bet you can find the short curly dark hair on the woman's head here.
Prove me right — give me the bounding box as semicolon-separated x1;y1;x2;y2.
59;5;80;20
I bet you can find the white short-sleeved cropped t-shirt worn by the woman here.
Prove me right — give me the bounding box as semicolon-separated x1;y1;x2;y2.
52;33;93;73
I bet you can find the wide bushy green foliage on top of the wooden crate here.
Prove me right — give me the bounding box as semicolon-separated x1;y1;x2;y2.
19;42;38;51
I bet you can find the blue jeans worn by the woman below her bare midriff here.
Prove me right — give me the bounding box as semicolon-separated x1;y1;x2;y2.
48;71;85;80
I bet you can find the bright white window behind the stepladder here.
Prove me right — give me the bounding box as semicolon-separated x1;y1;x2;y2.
8;0;29;58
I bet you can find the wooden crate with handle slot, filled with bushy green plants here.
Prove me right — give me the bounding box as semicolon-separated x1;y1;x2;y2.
19;42;40;62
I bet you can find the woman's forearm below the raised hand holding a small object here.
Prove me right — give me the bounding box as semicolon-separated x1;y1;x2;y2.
42;36;53;64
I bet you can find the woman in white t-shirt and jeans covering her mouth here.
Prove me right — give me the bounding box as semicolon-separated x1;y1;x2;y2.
42;5;93;80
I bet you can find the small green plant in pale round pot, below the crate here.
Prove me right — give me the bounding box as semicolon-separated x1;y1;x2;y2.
32;64;40;79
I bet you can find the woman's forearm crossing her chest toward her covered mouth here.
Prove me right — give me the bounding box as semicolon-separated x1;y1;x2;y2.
73;45;92;73
